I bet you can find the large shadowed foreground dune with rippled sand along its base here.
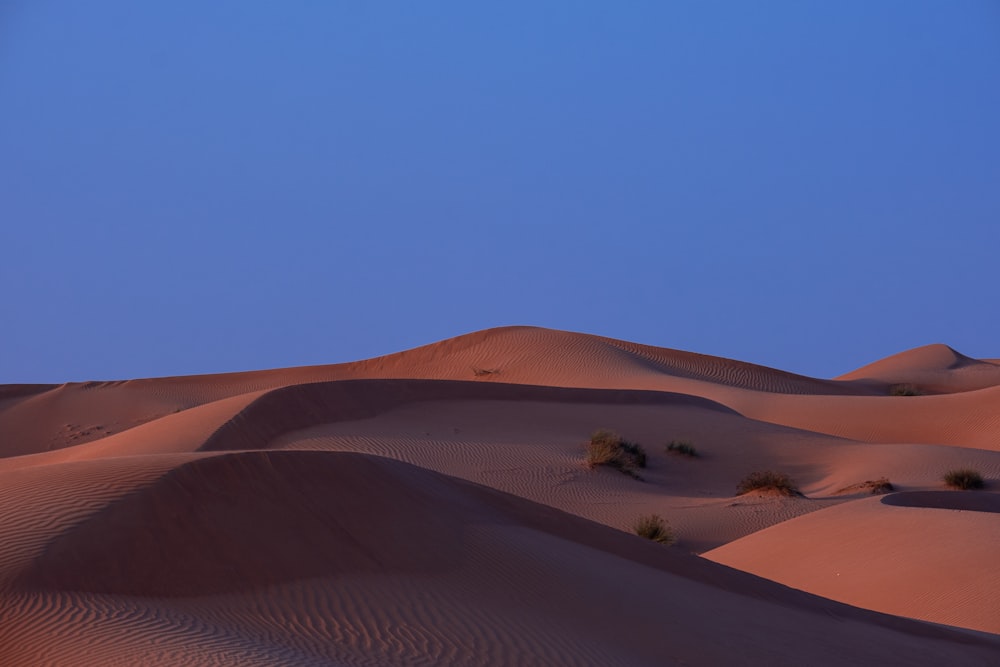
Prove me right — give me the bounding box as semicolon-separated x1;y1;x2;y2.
0;452;1000;665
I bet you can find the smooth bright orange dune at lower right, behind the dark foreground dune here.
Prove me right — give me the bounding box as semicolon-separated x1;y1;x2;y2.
705;491;1000;633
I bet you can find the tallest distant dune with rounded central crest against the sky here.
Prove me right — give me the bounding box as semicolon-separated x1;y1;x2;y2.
0;327;820;456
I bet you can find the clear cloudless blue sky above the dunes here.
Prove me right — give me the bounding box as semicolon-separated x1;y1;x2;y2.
0;0;1000;383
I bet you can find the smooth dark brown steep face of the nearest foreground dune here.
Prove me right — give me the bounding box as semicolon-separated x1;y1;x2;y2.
11;452;475;597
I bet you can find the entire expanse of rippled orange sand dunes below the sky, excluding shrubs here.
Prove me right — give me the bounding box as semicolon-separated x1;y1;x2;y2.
0;327;1000;667
